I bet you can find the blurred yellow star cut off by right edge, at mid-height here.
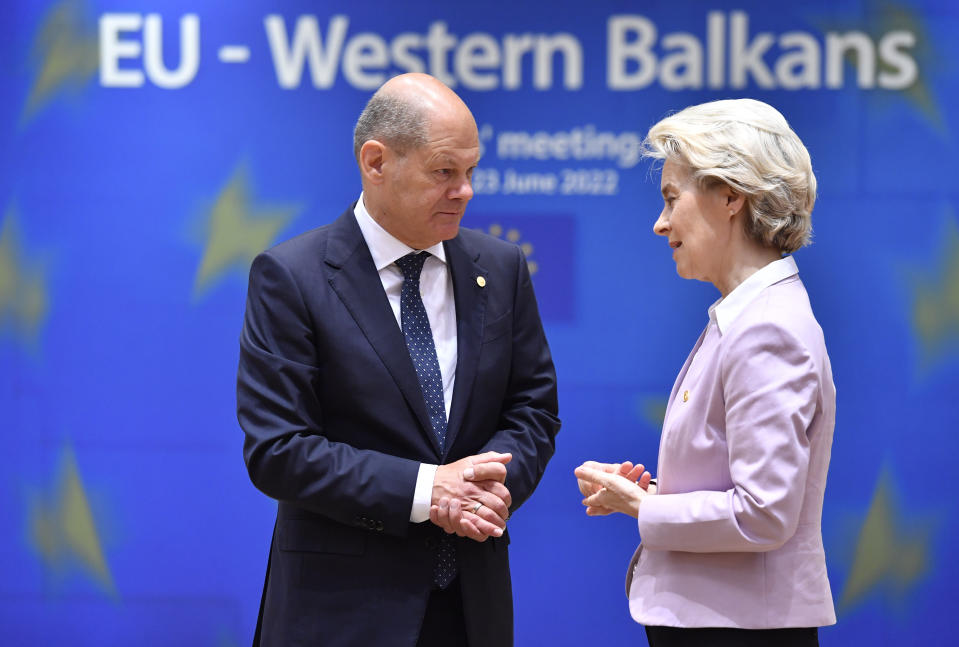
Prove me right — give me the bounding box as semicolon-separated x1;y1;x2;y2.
909;217;959;369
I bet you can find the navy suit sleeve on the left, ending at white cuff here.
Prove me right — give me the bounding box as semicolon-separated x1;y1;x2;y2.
237;252;419;535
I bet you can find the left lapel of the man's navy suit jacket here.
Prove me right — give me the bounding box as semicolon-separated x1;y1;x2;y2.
325;208;440;455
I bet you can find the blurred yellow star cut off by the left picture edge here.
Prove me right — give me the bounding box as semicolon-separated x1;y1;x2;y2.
0;207;50;344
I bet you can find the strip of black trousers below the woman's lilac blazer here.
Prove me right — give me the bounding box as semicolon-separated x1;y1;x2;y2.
646;627;819;647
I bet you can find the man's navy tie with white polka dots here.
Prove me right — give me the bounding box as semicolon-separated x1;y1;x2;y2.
396;252;456;589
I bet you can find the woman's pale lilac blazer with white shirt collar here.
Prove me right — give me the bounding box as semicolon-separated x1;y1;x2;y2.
627;257;836;629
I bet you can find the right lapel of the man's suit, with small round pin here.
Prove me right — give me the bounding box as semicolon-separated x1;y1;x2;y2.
445;236;489;452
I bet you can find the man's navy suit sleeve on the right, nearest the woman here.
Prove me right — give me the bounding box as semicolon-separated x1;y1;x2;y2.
482;247;560;512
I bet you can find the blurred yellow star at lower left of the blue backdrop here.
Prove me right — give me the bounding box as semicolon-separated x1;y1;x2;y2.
29;447;116;596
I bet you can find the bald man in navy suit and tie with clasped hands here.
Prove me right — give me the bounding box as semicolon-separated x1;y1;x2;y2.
237;74;560;647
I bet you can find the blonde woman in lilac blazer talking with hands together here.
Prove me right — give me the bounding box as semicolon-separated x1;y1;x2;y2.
575;99;836;647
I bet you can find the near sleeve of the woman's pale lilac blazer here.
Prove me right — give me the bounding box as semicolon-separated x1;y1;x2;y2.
638;322;820;552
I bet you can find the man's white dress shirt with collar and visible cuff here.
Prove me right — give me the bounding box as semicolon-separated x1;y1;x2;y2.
353;193;456;523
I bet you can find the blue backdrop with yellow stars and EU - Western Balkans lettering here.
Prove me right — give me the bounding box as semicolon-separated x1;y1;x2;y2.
0;0;959;646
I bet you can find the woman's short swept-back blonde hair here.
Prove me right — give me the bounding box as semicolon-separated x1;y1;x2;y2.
643;99;816;253
